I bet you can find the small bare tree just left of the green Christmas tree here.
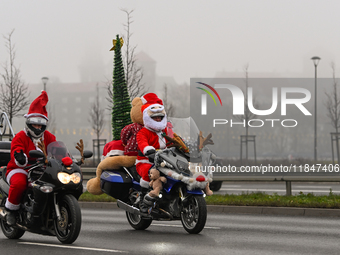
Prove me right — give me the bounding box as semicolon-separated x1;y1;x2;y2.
88;84;105;163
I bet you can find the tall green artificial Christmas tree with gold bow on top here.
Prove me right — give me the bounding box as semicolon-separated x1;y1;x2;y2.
111;35;132;140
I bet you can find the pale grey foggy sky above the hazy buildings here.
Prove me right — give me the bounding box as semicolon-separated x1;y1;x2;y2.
0;0;340;83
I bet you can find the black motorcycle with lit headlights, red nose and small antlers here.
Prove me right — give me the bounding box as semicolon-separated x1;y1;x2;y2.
0;142;92;244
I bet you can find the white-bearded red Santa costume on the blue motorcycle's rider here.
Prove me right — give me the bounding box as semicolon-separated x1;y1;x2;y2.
136;93;167;188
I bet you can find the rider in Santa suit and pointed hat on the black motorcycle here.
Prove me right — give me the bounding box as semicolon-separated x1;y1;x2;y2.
5;91;56;225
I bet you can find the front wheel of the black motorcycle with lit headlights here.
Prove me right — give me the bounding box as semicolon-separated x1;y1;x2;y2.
54;195;81;244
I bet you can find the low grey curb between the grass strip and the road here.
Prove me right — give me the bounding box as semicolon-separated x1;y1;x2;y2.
79;201;340;217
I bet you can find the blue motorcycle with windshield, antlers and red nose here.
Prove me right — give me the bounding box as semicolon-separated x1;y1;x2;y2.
101;118;213;234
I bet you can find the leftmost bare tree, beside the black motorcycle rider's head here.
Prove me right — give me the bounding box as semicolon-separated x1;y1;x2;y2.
0;29;30;124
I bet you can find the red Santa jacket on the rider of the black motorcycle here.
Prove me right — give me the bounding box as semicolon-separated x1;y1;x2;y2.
6;130;56;176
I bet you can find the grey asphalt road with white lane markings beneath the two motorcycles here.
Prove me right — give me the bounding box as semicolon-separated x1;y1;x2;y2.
0;209;340;255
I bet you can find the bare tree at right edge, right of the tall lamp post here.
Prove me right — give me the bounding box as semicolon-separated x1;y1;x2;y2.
325;62;340;162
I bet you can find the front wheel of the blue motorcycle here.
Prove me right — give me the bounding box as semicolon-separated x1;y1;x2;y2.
181;196;207;234
